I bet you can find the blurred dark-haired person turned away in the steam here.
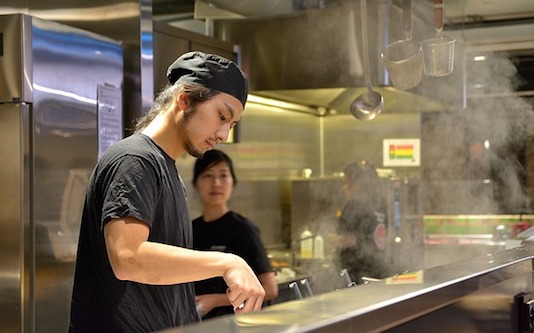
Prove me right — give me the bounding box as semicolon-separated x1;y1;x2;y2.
330;161;389;284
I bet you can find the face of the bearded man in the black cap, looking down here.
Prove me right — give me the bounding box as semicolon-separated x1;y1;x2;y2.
181;93;243;157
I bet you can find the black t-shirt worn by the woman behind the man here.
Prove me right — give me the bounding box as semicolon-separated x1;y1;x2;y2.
193;211;272;319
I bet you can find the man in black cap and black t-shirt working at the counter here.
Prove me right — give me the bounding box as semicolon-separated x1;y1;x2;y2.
69;52;265;333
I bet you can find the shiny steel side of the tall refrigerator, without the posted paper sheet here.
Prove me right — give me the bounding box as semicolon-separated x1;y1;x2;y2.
28;18;123;332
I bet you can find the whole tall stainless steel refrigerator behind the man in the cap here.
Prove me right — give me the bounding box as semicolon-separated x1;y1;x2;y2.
0;14;123;333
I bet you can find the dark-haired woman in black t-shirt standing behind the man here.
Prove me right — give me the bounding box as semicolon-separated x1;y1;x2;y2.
193;149;278;319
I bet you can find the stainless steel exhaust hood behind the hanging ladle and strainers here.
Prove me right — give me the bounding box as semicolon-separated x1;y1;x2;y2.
204;0;461;116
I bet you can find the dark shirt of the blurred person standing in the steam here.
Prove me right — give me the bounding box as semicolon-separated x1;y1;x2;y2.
337;199;388;283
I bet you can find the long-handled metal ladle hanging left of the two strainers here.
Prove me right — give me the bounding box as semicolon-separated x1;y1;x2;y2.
350;0;384;120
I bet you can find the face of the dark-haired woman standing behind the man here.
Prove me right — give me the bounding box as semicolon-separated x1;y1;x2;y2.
196;162;234;205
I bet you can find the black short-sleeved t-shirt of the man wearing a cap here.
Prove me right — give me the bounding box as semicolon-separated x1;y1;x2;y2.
70;134;199;333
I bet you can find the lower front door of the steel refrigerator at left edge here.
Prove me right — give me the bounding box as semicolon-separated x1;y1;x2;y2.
0;103;33;333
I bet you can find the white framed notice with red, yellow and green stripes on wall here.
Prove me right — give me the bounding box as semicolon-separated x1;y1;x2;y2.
382;139;421;167
